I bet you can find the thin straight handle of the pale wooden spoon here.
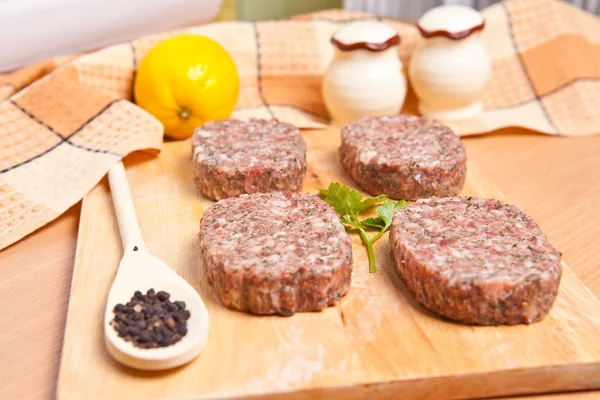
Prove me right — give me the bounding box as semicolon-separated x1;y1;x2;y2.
108;161;144;252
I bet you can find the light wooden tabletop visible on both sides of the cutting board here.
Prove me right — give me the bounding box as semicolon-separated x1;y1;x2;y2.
0;129;600;400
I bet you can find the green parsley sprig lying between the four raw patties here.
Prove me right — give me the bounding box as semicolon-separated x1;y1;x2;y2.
319;182;408;273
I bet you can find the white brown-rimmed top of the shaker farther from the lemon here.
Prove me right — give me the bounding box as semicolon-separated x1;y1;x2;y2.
417;4;485;40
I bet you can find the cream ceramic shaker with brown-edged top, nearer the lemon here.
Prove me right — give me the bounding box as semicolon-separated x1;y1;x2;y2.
322;20;406;125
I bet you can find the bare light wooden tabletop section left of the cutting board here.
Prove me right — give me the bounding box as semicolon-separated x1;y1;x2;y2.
0;204;81;400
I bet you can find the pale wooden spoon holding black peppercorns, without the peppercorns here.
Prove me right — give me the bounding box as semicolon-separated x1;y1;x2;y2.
104;162;208;370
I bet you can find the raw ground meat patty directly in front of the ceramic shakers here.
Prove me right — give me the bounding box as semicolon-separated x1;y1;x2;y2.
340;115;467;200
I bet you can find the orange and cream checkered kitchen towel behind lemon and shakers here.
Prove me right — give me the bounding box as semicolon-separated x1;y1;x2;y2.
0;0;600;249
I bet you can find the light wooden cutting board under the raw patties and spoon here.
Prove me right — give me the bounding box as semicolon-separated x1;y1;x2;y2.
57;129;600;400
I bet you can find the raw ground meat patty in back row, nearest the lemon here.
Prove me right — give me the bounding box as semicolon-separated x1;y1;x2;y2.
192;118;306;200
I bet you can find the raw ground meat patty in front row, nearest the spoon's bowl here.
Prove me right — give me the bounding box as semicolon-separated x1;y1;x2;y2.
200;192;352;315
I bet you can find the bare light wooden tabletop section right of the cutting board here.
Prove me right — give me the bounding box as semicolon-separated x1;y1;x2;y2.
463;127;600;296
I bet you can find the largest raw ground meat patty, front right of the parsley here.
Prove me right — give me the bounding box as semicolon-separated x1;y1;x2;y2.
390;197;562;325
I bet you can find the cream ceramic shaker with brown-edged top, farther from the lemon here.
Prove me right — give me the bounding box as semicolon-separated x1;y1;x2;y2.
409;5;491;120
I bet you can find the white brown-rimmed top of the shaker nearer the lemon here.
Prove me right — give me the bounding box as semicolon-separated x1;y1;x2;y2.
331;20;400;51
